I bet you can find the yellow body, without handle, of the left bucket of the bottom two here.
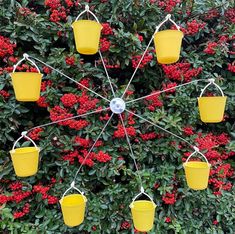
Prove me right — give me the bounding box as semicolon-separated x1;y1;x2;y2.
60;194;87;227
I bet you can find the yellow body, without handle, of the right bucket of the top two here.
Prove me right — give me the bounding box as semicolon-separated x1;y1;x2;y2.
154;30;184;64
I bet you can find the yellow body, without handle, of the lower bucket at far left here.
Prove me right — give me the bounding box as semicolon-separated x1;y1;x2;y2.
10;147;40;177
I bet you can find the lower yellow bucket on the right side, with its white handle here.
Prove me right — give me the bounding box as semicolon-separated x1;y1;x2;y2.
183;150;211;190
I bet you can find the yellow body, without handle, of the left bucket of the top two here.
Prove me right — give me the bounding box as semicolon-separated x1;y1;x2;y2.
72;20;102;55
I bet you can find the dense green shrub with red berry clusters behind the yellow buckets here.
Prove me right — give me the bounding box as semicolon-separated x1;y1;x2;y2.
0;0;235;234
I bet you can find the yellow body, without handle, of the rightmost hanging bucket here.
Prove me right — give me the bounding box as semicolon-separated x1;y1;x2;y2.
198;96;227;123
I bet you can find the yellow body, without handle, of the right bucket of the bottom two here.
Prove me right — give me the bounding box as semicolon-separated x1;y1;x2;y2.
130;200;156;232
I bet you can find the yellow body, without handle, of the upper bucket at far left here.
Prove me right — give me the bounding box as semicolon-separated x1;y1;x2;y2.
10;72;42;102
